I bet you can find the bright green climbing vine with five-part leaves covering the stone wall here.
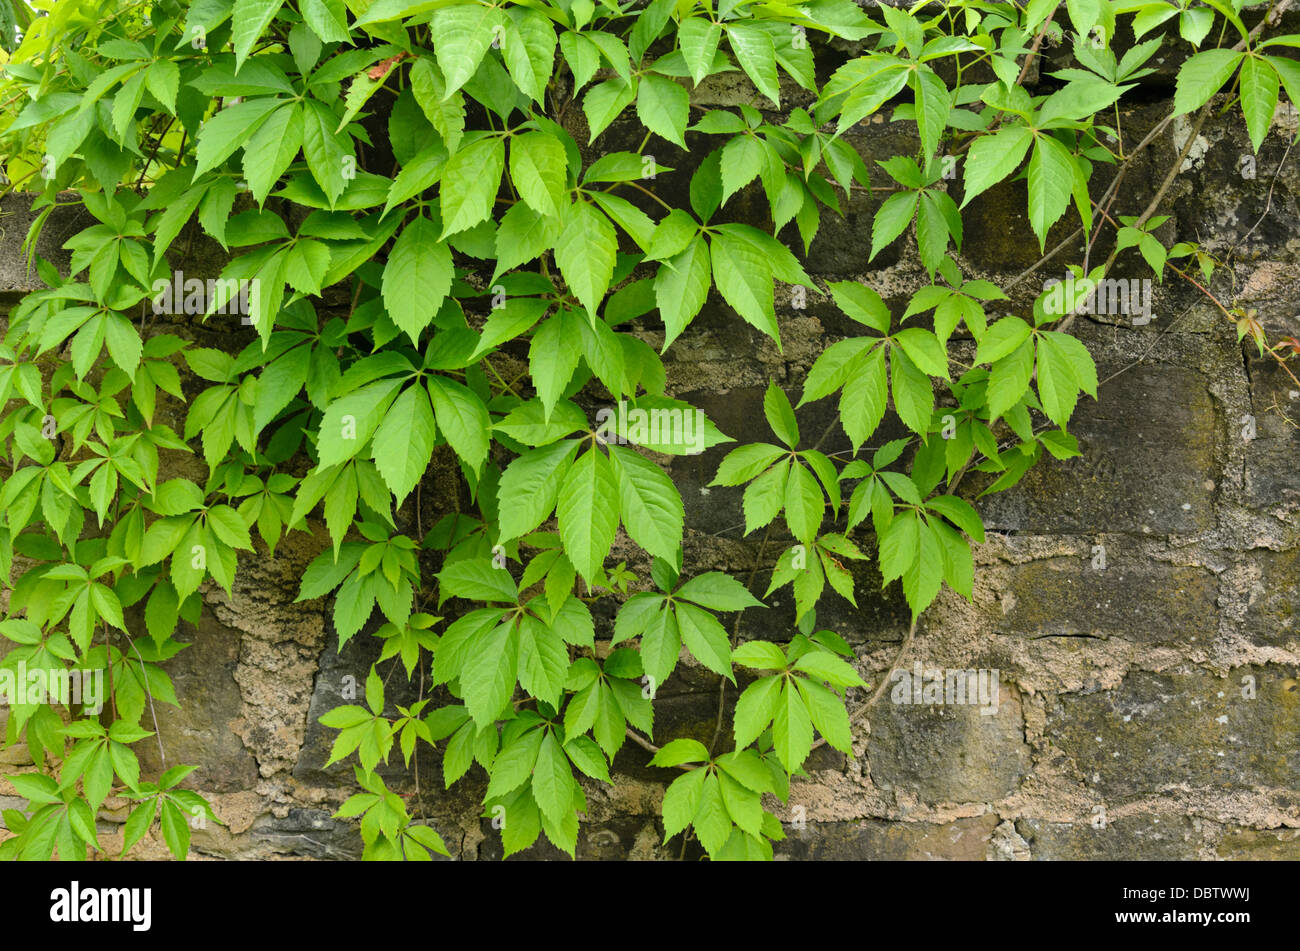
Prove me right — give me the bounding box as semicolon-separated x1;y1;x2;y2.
0;0;1300;859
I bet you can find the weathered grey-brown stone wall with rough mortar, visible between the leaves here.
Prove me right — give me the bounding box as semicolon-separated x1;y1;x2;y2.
0;14;1300;860
